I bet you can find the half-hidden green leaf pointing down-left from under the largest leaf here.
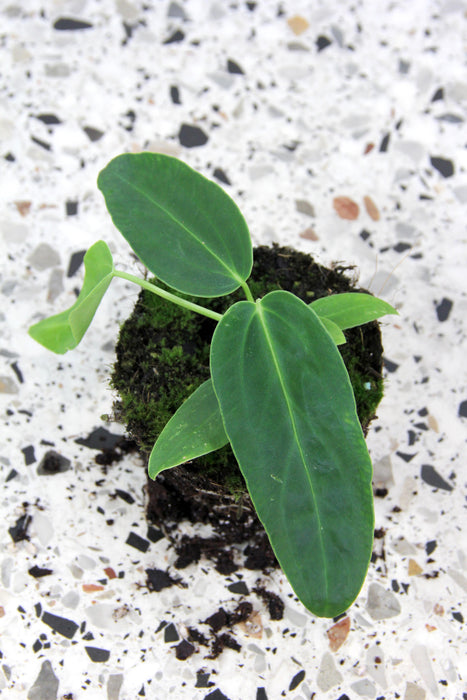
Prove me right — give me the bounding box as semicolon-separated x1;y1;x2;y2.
149;379;229;479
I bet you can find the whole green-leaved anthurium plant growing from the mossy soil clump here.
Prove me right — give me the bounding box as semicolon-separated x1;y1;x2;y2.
29;153;397;617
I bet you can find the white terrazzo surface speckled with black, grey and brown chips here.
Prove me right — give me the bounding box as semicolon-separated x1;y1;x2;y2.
0;0;467;700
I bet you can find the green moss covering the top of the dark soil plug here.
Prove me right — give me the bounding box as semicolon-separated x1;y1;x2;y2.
111;247;383;498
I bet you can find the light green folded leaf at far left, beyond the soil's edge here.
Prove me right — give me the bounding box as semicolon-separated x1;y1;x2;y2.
29;241;114;355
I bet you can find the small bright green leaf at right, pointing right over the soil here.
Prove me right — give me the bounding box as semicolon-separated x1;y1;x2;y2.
310;292;397;331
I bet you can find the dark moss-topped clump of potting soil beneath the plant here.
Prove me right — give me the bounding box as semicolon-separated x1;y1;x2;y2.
111;245;383;575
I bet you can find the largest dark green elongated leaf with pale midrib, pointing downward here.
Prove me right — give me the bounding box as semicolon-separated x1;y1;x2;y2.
211;291;374;617
